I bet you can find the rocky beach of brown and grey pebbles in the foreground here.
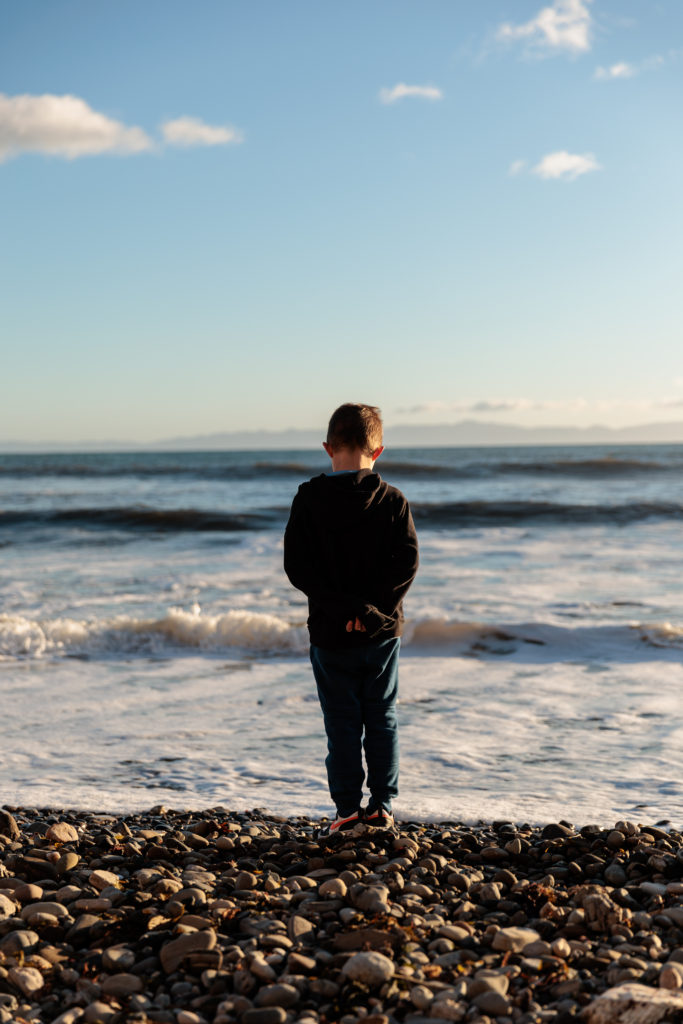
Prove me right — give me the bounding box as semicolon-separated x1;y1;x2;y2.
0;806;683;1024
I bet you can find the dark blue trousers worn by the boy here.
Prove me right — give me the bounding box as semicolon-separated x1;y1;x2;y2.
310;637;400;817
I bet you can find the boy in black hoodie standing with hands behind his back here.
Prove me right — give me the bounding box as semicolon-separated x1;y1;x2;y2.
285;403;418;835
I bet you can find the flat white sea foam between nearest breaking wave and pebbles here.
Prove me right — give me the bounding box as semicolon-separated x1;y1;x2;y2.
0;648;683;826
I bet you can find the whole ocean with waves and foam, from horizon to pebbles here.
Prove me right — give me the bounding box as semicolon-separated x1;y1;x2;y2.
0;445;683;828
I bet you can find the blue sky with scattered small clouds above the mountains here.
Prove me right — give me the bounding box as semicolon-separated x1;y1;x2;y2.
0;0;683;441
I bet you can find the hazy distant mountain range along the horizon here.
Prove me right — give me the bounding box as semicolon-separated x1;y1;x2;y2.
0;420;683;454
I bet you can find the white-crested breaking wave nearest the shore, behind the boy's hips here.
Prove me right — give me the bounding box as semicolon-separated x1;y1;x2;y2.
0;605;683;660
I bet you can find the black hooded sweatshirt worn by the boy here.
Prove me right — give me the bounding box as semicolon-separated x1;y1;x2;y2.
285;469;418;650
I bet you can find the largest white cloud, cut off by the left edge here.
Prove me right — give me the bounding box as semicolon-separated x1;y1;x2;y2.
0;93;154;163
